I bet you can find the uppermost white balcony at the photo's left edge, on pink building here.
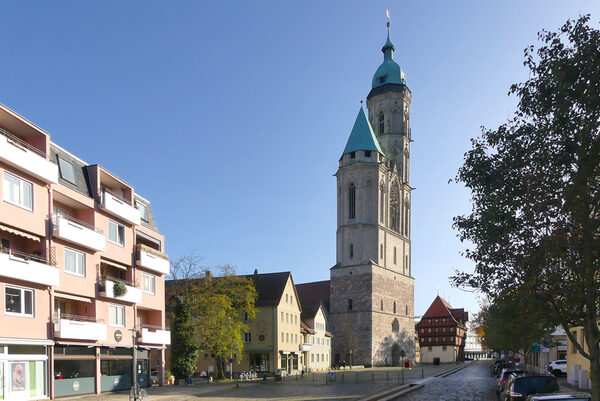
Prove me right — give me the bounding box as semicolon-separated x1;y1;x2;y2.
0;128;58;184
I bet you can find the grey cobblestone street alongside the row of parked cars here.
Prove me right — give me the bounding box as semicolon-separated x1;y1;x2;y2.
398;361;496;401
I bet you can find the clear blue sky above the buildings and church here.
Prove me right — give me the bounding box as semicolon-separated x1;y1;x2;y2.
0;0;600;314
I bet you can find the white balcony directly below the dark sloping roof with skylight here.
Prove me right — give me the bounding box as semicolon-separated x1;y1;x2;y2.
52;214;106;251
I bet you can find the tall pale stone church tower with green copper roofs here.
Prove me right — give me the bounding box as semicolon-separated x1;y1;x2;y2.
330;22;415;366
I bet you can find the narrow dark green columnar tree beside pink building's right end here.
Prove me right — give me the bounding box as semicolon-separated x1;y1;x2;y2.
171;297;199;378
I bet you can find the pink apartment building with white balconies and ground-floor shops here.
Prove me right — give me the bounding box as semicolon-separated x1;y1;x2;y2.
0;105;170;400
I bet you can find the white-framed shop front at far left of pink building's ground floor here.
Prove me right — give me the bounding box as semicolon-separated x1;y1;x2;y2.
0;339;52;400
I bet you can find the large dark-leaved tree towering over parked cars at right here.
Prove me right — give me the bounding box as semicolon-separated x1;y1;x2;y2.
453;15;600;401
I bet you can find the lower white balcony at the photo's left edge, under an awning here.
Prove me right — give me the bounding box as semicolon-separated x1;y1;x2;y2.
0;248;59;286
